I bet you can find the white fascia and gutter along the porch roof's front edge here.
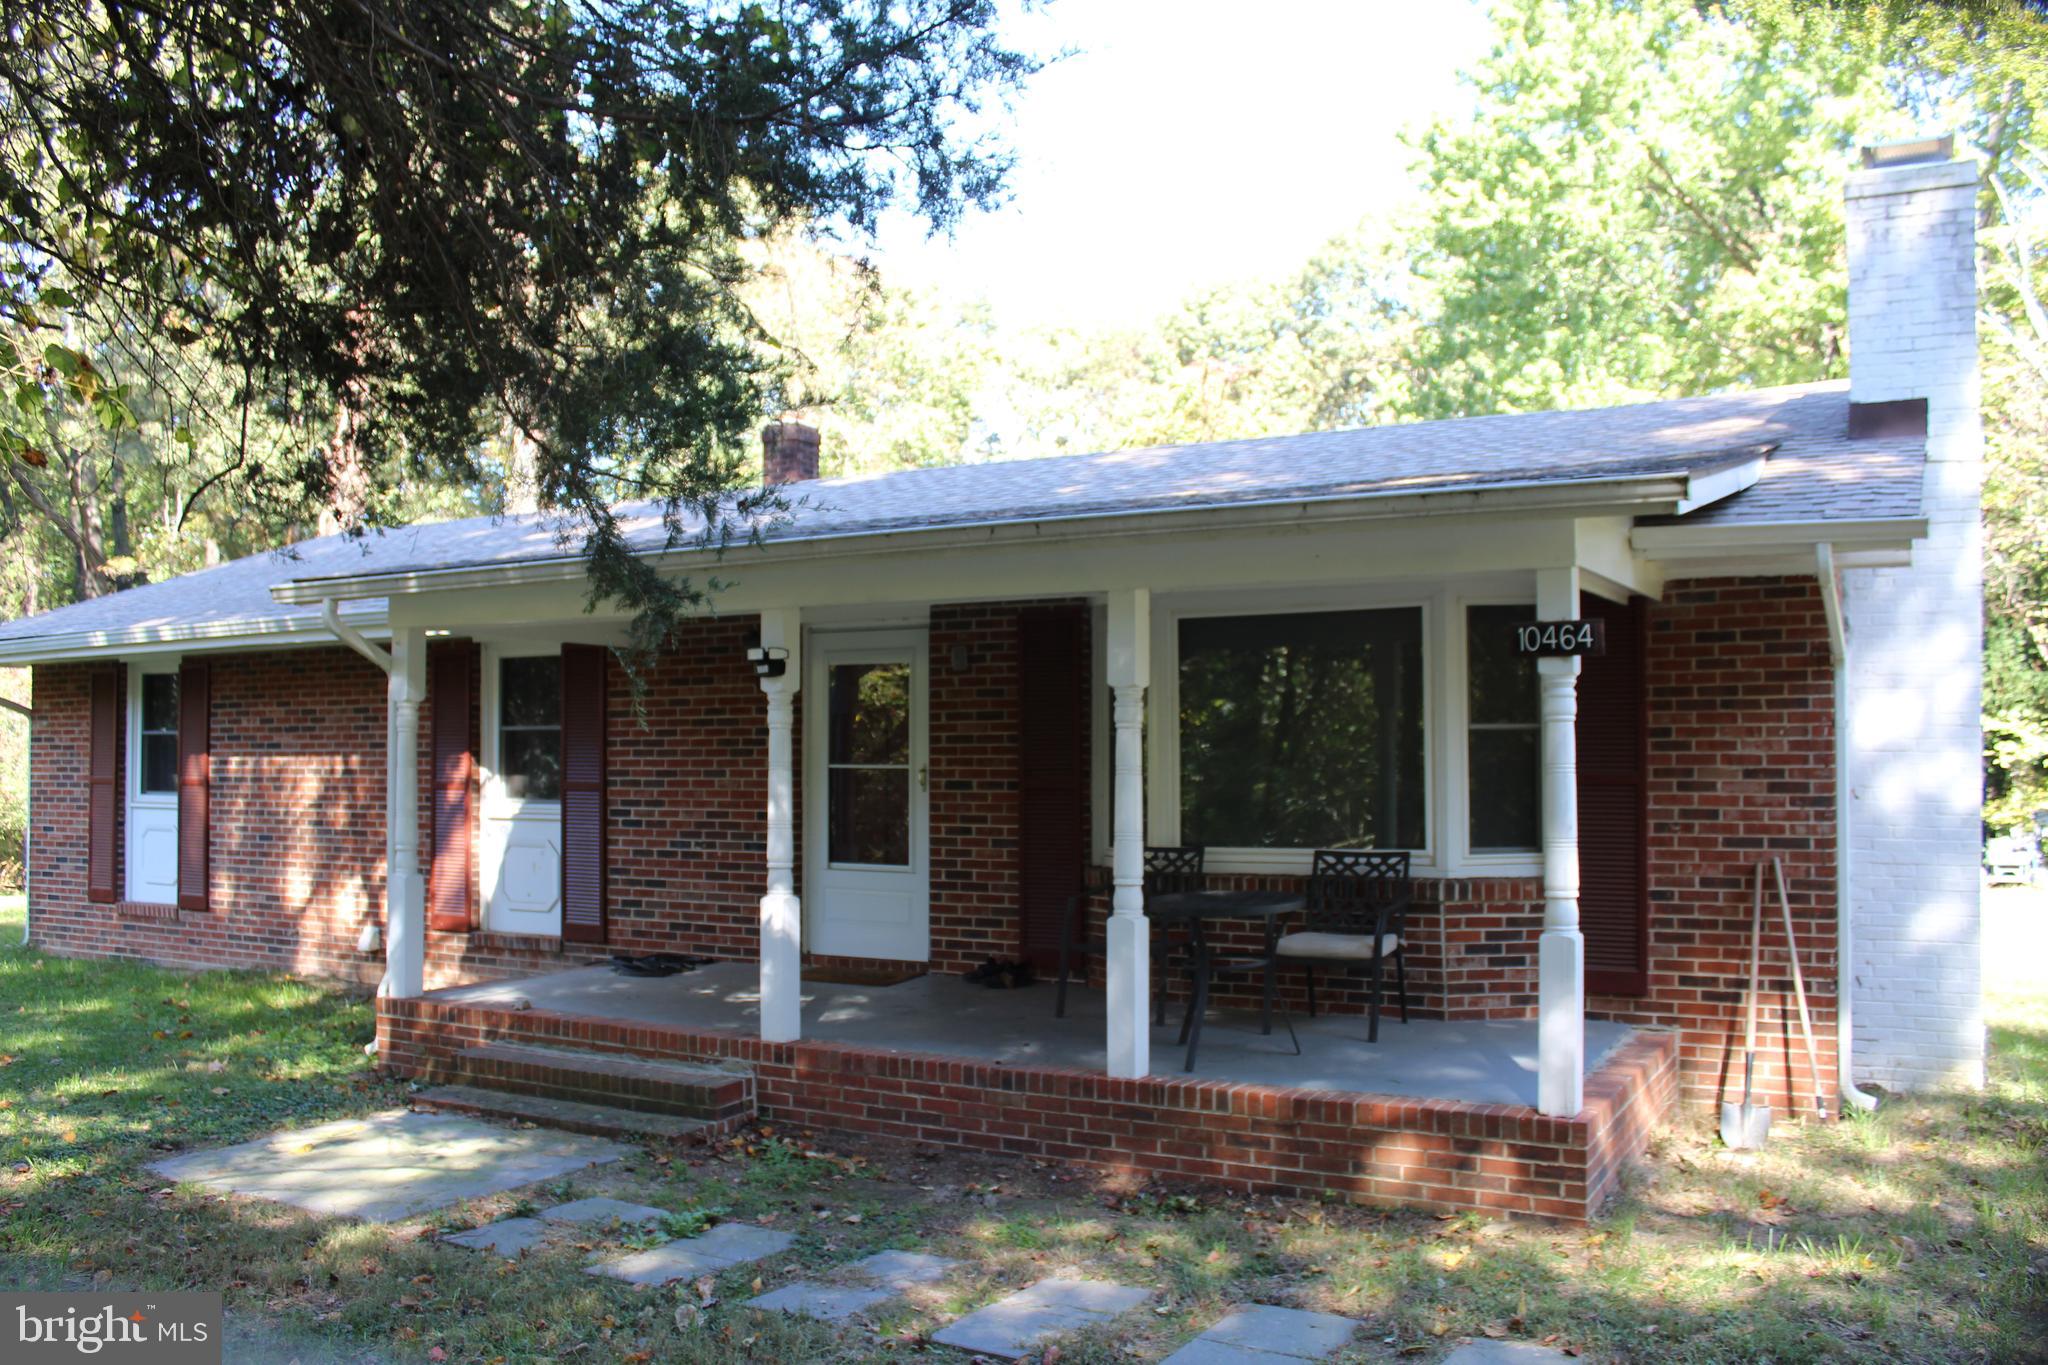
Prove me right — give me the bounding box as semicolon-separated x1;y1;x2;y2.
270;467;1735;606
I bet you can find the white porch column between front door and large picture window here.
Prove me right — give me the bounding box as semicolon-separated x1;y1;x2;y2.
1106;587;1151;1076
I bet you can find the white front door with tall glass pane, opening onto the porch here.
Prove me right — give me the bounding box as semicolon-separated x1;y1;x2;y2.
803;630;932;962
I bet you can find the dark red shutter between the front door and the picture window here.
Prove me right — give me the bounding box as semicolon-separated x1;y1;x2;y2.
1018;608;1087;966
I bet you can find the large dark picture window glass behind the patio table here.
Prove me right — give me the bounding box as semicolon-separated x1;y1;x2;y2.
1180;608;1427;849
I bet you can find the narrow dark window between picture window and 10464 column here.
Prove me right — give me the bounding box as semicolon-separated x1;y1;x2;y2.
1464;606;1542;853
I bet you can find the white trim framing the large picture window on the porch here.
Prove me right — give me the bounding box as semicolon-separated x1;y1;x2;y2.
1130;573;1542;878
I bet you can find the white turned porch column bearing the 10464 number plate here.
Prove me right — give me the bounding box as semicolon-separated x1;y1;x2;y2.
1536;569;1585;1117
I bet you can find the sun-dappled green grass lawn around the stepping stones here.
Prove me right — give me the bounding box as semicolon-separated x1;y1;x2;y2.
0;907;2048;1365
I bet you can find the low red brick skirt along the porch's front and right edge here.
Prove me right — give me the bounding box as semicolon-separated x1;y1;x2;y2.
377;999;1677;1222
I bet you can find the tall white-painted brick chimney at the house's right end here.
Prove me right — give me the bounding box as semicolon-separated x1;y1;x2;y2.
1843;137;1985;1091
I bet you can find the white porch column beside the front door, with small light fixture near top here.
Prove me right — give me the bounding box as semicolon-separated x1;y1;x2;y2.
760;610;803;1044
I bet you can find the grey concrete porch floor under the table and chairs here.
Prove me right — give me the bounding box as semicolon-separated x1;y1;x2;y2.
428;962;1632;1105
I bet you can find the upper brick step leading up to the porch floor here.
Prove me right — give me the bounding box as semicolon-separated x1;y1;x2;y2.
448;1042;754;1124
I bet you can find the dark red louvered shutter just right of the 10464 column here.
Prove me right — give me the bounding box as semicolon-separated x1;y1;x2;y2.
1579;593;1651;995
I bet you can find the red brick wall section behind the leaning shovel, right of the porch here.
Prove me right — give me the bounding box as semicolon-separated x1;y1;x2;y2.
1587;579;1835;1113
